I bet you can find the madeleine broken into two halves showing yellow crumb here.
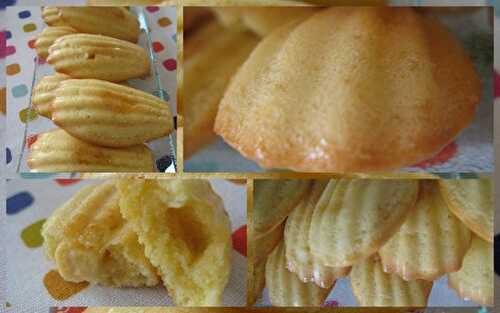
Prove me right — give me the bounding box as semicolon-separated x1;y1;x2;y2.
42;179;232;306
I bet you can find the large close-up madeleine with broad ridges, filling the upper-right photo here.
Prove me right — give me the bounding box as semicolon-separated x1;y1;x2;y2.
214;7;481;172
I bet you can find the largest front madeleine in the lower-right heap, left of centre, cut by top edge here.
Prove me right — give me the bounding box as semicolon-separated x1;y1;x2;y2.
309;179;418;267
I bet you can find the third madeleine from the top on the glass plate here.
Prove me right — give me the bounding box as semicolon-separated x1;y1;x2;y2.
52;79;174;147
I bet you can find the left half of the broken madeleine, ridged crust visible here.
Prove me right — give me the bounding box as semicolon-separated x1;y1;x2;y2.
42;181;160;287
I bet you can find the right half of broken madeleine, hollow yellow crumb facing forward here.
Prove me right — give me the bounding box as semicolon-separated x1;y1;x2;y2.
117;179;232;306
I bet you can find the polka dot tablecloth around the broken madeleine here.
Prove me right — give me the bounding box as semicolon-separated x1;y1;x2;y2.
2;179;247;313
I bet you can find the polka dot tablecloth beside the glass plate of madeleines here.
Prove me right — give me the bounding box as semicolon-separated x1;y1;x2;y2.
2;6;177;176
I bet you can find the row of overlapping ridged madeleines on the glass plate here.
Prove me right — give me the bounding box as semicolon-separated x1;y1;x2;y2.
28;7;173;172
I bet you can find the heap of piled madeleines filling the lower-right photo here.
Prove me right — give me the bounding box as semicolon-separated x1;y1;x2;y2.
249;179;494;307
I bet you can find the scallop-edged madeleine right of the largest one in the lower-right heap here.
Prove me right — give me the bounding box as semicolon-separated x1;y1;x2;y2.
378;180;471;281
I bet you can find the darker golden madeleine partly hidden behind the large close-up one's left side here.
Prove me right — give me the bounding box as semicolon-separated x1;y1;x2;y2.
183;22;259;158
